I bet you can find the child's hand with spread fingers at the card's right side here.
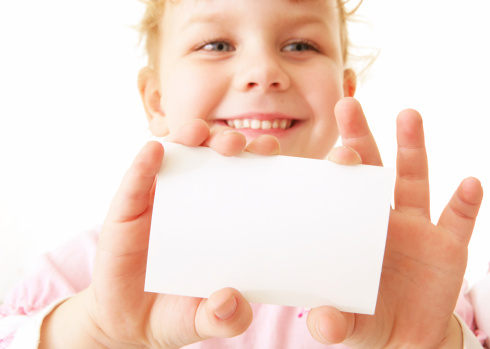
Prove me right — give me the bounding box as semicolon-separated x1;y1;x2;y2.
308;98;483;349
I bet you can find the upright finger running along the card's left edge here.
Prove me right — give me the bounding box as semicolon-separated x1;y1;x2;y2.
94;142;163;290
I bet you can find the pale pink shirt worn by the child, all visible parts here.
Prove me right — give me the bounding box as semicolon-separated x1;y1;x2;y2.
0;228;490;349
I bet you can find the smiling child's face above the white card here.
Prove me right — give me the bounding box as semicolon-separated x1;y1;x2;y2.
147;0;355;158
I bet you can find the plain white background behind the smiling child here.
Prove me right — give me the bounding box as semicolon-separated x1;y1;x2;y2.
0;0;490;299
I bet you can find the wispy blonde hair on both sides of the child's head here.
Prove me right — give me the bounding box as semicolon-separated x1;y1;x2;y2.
138;0;363;68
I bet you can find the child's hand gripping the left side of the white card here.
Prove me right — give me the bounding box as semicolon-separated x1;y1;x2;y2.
40;120;280;349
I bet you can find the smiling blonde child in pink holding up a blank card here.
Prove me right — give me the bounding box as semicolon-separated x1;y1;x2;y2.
2;0;488;348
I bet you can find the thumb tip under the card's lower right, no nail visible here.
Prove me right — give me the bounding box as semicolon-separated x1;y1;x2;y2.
306;306;355;344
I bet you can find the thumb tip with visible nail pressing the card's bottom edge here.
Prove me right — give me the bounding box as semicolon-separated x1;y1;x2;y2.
195;288;253;340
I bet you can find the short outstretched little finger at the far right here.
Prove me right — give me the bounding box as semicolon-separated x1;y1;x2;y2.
438;177;483;245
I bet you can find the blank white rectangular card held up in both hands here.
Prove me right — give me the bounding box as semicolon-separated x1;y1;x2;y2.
145;143;393;314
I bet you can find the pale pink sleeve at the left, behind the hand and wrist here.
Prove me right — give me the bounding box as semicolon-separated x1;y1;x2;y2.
0;228;100;342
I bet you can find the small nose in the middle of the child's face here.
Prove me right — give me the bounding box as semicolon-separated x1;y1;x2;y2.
234;50;290;92
